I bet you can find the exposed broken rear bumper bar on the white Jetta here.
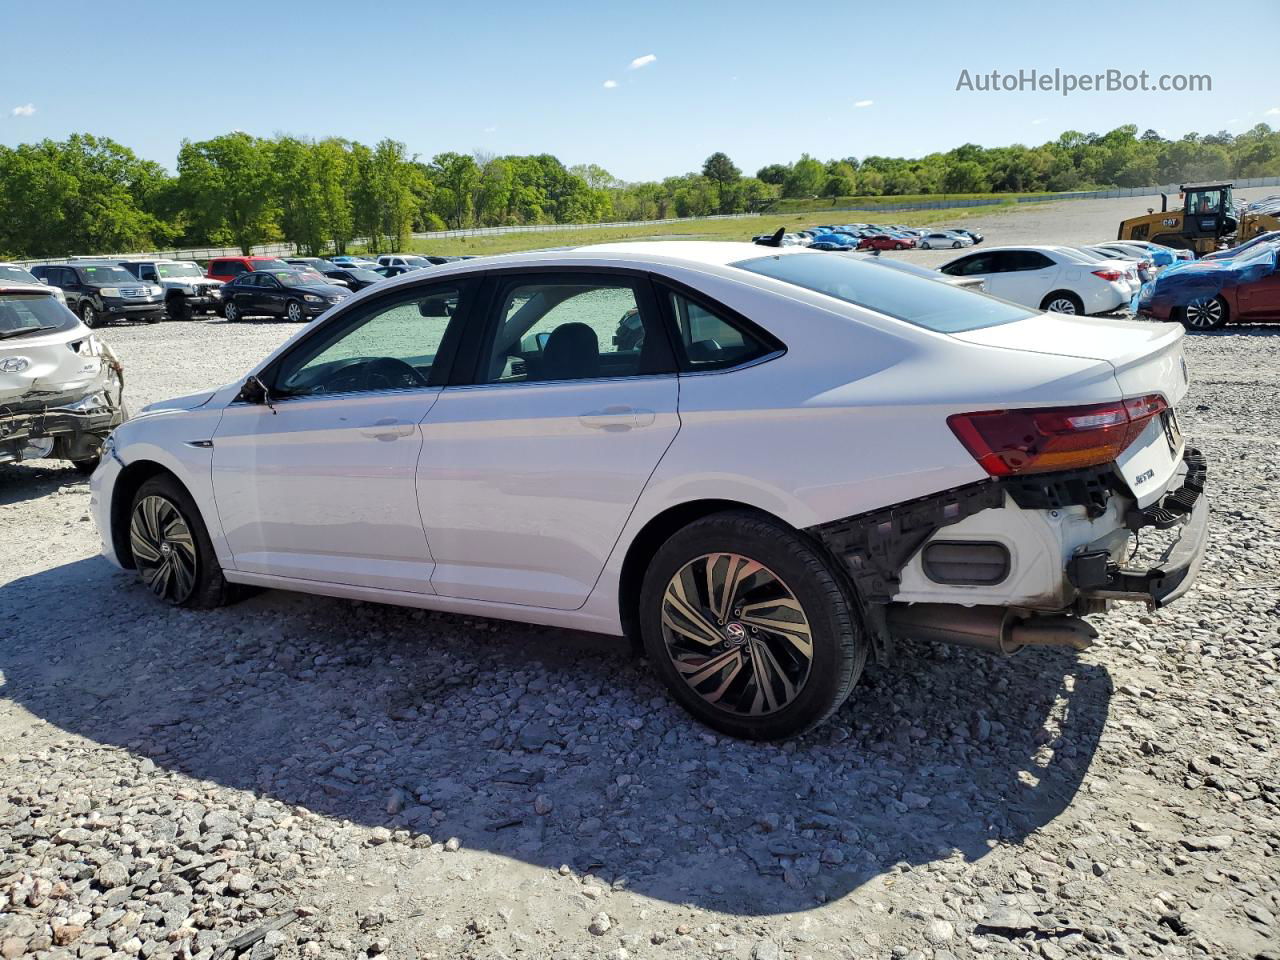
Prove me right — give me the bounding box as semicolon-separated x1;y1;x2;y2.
1068;447;1208;608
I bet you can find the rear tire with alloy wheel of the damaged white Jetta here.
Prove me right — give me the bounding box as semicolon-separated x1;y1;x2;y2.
640;511;868;740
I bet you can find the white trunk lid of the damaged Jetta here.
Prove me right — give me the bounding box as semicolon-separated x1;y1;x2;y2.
952;314;1188;507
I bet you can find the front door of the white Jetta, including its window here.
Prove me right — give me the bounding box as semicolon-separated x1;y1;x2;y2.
212;280;471;594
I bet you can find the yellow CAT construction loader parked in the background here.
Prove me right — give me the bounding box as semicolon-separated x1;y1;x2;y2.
1116;183;1280;256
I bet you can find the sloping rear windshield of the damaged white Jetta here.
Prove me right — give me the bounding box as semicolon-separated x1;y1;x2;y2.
733;253;1034;333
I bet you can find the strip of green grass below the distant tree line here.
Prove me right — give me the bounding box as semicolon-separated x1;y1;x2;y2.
394;201;1015;256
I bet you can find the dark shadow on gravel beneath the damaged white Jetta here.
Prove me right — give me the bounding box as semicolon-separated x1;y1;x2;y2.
0;558;1112;915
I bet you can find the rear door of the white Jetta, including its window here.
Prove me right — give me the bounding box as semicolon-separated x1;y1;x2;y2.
419;270;680;609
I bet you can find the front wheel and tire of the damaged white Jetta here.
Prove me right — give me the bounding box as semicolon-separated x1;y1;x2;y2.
129;475;232;609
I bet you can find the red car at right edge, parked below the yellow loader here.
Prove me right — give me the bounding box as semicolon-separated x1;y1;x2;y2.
1138;245;1280;330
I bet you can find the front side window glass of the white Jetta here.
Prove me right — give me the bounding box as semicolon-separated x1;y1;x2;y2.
274;284;462;397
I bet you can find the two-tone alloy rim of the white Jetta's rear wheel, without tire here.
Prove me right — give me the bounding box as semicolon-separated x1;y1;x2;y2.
662;553;813;717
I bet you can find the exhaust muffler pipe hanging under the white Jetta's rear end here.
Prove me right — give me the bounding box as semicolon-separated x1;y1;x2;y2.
887;603;1098;657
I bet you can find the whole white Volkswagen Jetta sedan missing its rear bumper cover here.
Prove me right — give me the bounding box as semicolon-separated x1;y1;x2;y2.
92;242;1207;739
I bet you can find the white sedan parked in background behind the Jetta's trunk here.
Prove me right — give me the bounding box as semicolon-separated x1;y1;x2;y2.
938;244;1137;315
